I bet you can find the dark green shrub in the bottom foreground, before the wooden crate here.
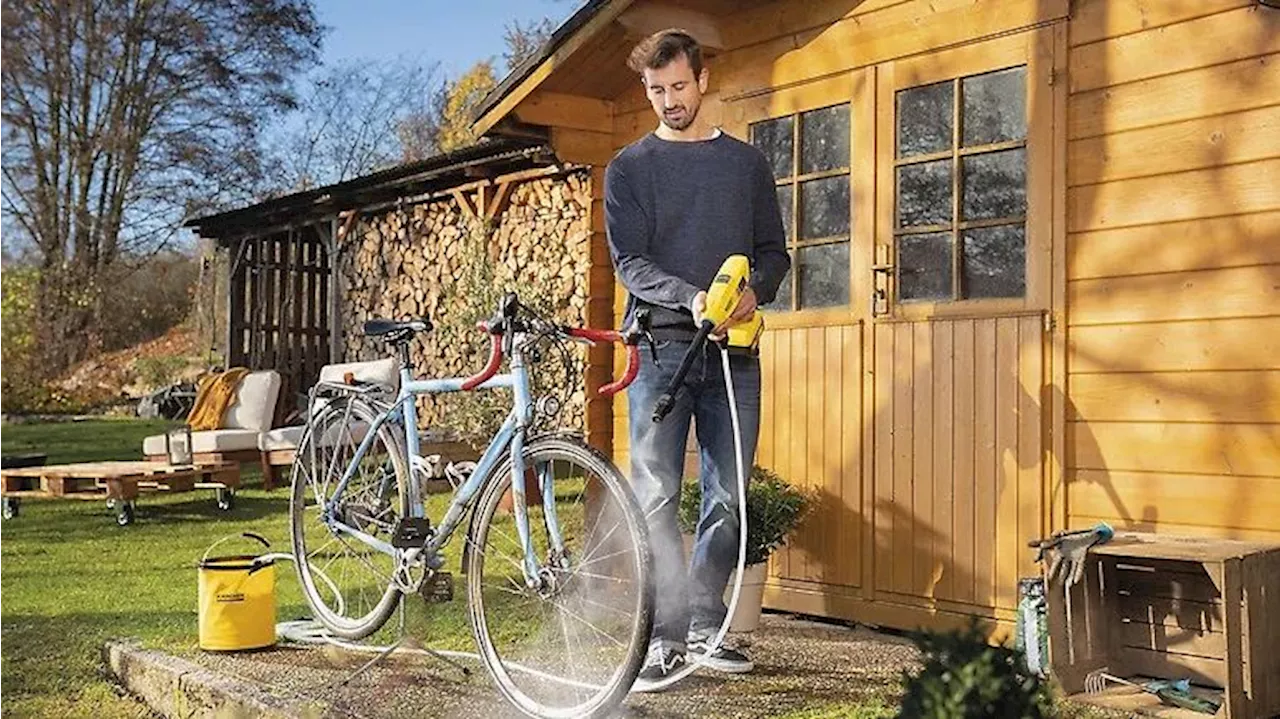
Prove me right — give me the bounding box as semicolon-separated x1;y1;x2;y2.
897;620;1052;719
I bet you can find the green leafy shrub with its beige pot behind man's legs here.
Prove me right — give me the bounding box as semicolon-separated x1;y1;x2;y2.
680;466;810;632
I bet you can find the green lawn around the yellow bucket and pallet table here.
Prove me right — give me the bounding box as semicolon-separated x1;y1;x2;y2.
0;420;499;718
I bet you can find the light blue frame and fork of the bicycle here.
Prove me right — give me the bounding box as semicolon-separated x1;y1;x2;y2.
321;336;564;587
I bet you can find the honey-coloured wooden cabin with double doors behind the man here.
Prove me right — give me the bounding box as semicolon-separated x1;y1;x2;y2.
476;0;1280;627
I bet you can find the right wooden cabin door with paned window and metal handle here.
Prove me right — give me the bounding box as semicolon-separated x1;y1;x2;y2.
865;29;1053;618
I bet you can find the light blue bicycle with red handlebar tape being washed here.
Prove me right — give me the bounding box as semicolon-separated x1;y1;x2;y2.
291;294;654;718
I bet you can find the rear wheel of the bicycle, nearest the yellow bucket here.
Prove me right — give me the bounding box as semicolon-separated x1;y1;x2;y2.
289;398;408;640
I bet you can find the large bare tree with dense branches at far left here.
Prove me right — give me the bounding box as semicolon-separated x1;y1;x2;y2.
0;0;321;372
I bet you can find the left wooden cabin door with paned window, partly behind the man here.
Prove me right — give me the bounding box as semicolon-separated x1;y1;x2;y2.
742;70;876;593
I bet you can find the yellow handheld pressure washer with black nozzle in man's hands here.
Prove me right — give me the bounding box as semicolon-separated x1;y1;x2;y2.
653;255;764;422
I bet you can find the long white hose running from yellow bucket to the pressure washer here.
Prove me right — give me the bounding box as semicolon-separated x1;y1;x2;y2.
262;345;746;691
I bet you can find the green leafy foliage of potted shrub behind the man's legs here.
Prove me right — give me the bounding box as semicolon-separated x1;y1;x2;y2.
680;466;812;567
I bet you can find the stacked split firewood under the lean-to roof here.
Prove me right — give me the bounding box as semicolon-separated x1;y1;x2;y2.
338;171;591;429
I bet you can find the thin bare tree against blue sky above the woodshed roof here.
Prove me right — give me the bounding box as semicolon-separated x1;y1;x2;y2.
264;60;438;192
